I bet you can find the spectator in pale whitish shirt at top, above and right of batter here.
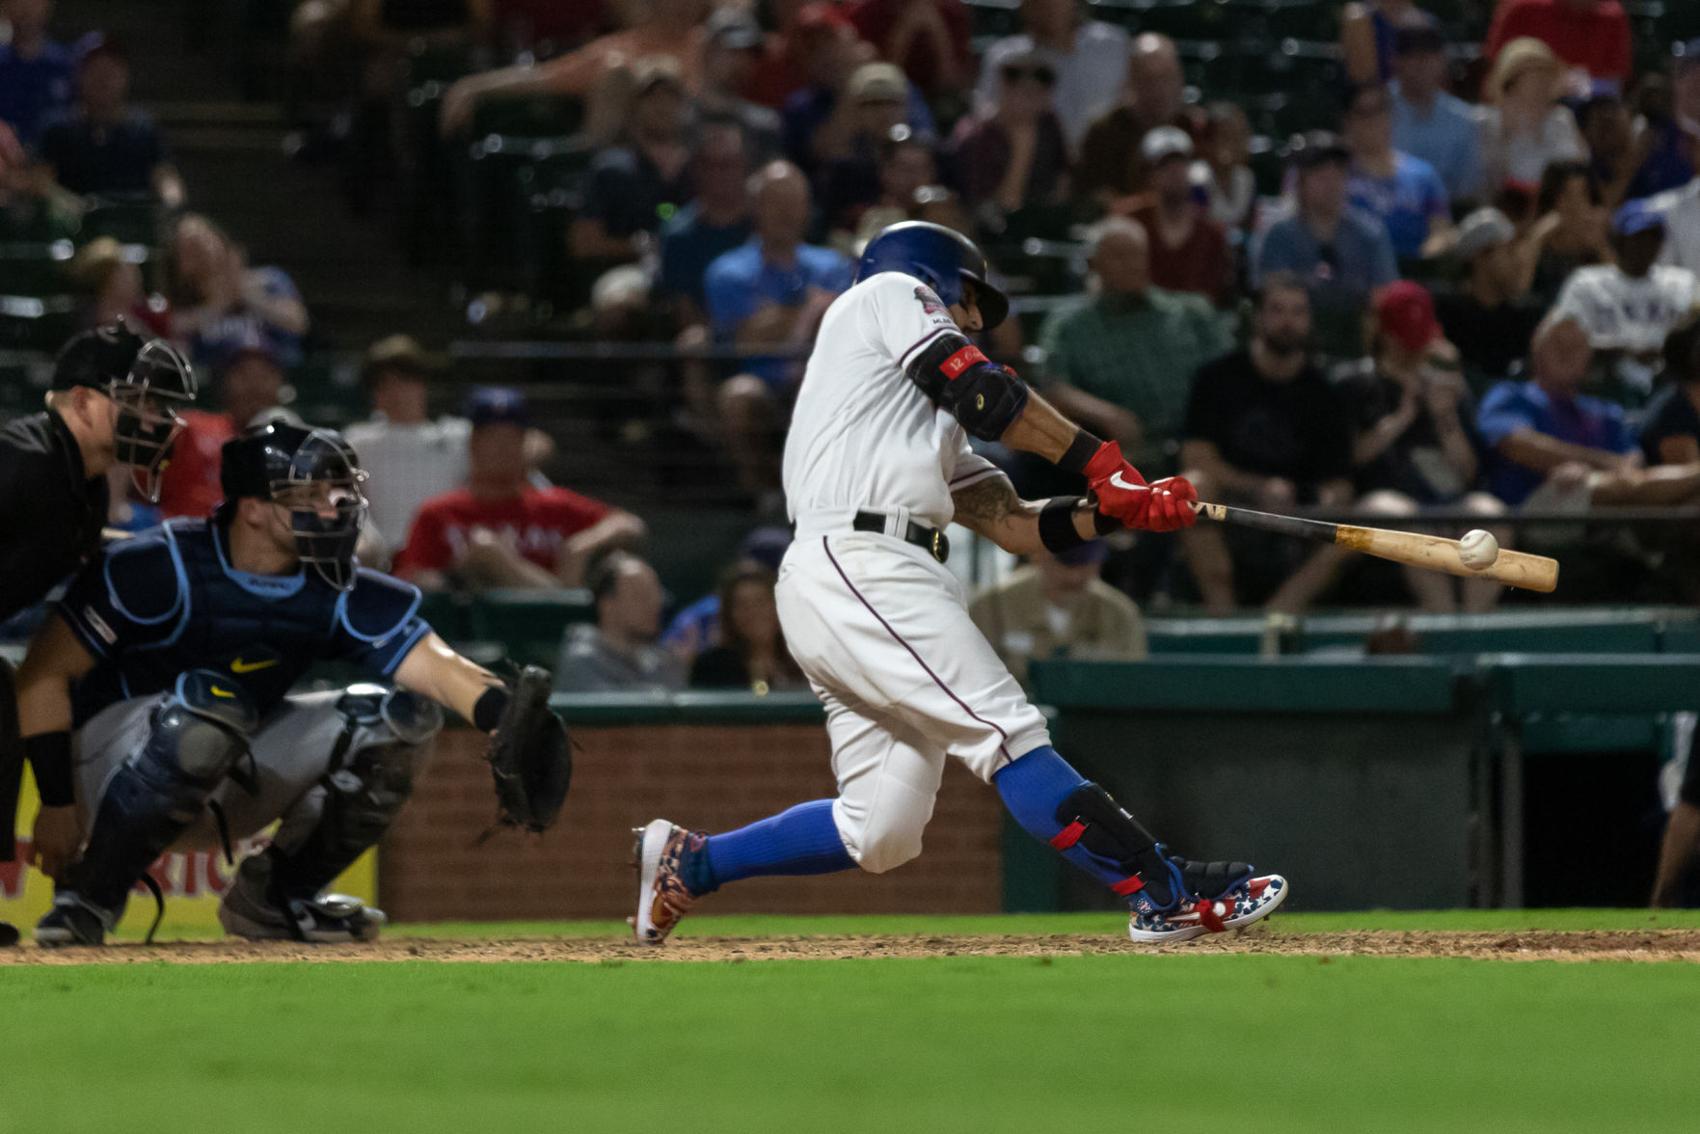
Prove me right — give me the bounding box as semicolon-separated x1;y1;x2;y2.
976;0;1129;146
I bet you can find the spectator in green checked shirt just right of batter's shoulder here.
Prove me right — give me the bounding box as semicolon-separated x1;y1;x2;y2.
1039;218;1229;473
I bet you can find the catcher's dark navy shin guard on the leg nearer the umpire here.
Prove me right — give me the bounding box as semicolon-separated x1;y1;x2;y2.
61;670;257;925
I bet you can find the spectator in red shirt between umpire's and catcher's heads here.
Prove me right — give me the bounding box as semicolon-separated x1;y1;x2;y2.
160;337;284;517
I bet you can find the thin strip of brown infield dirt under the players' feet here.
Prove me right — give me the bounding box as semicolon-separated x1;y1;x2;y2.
0;928;1700;966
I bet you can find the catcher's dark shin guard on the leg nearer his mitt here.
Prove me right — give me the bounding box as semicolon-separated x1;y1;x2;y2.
264;685;442;899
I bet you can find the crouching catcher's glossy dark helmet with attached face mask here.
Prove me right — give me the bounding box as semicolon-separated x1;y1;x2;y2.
219;420;366;590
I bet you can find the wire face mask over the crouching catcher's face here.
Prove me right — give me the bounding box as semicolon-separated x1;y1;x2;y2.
270;425;366;590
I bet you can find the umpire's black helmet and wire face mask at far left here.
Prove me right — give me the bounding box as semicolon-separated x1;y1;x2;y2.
53;320;196;500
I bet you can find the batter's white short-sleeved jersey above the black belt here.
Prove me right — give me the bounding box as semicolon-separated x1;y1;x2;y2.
784;272;998;529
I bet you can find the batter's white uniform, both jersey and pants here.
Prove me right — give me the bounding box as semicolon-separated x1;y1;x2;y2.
774;272;1051;872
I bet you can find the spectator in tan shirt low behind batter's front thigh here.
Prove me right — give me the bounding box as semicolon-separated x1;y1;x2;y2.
967;541;1148;685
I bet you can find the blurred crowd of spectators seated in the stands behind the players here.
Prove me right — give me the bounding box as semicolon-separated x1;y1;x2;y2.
0;0;1700;683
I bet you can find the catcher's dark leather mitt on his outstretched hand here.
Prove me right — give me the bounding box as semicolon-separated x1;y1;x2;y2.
490;665;573;833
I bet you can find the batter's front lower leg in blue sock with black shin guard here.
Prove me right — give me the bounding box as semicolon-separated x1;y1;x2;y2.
991;746;1183;910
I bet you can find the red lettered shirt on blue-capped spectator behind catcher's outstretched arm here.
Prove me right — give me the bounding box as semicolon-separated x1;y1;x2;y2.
393;486;612;576
